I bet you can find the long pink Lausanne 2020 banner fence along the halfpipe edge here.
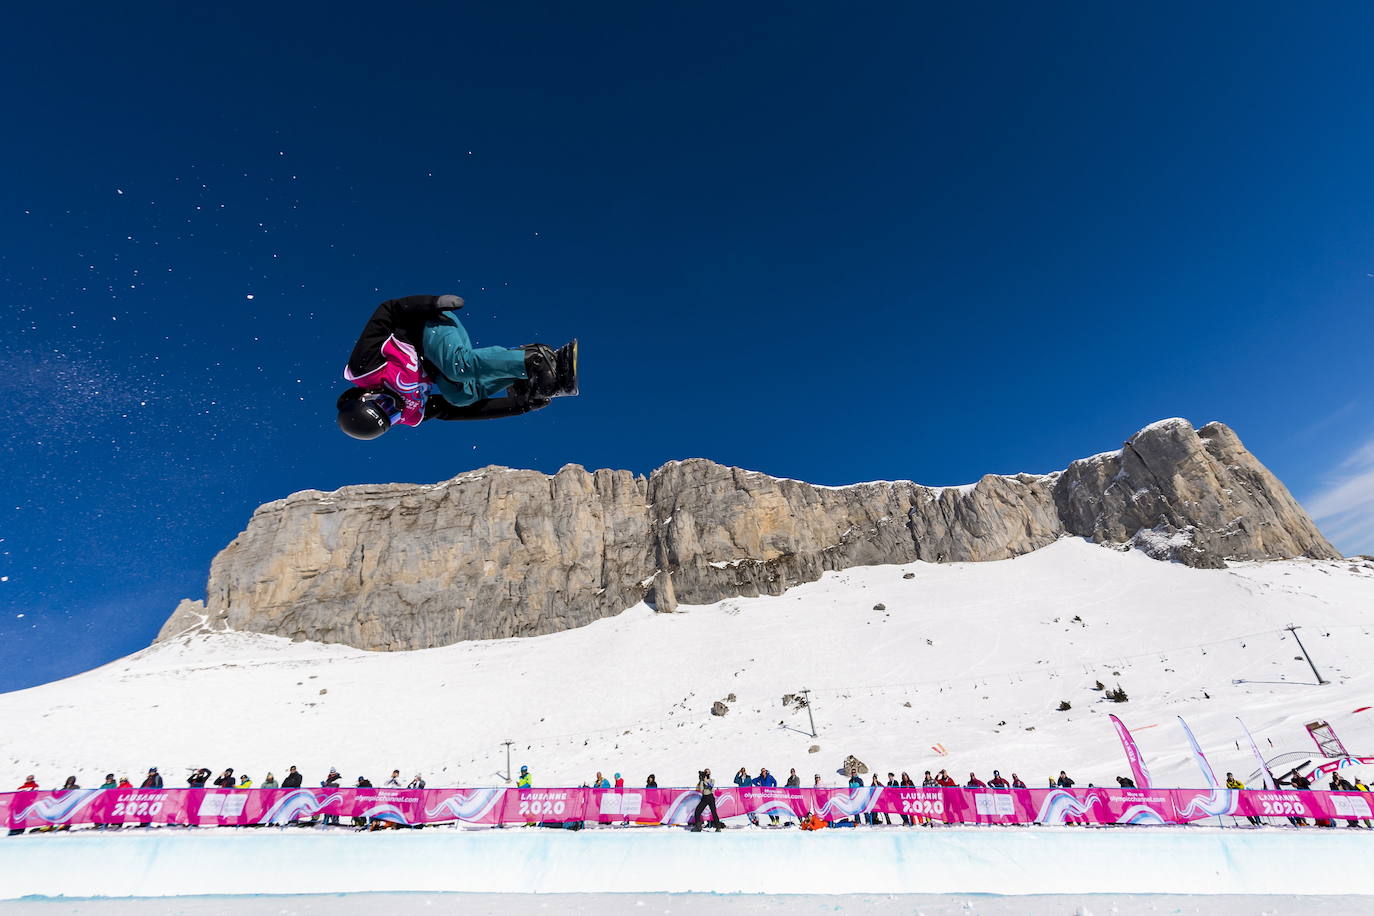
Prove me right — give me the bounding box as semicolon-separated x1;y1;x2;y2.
0;786;1374;831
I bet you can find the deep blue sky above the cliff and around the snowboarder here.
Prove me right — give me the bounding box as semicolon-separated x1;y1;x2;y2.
0;3;1374;689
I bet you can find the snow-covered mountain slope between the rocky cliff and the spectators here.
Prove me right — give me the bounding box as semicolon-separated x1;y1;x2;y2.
0;538;1374;787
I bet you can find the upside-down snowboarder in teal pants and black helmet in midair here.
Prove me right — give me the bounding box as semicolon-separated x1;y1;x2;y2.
337;294;577;439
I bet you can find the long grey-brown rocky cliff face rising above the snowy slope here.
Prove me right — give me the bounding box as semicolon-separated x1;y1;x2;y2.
158;420;1340;650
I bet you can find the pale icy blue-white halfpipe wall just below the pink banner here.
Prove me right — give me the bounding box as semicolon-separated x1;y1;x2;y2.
0;827;1374;898
